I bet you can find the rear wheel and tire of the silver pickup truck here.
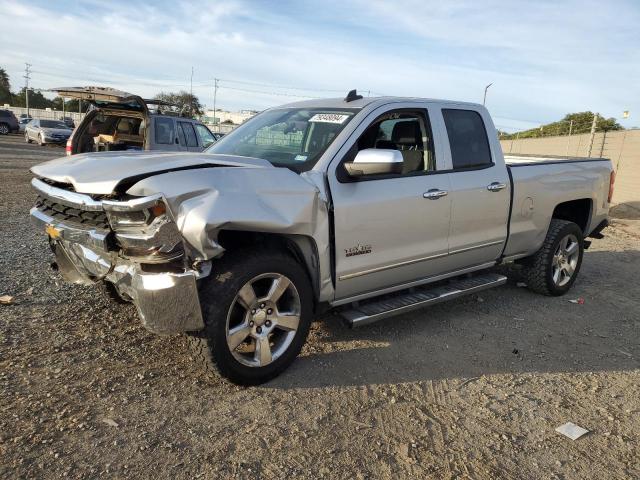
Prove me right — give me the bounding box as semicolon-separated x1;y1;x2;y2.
523;218;584;296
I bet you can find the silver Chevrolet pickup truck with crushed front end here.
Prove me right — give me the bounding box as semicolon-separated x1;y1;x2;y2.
31;91;614;384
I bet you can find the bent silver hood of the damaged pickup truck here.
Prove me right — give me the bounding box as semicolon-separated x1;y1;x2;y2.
31;152;273;194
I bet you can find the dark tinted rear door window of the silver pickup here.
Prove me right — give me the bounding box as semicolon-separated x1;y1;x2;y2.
442;109;493;170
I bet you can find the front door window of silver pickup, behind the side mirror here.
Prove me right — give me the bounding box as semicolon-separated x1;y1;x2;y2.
345;110;436;179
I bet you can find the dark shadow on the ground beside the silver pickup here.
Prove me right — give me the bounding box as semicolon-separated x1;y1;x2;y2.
263;250;640;389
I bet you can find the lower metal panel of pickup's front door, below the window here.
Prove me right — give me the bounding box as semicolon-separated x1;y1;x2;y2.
332;174;451;298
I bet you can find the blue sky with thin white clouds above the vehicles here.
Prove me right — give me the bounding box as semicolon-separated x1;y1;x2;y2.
0;0;640;131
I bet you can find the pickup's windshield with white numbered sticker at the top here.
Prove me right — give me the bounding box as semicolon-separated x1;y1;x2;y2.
206;108;358;172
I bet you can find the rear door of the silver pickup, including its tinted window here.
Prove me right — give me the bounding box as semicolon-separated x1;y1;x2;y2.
442;108;511;270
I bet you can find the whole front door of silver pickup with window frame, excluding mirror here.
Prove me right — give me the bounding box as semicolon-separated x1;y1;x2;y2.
329;108;451;300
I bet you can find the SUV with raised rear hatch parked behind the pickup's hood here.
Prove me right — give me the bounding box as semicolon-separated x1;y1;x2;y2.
53;87;216;155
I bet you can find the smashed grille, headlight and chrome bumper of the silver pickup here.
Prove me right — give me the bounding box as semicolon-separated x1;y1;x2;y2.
30;179;208;334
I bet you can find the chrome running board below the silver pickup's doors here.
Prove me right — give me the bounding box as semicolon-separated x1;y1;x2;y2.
340;273;507;327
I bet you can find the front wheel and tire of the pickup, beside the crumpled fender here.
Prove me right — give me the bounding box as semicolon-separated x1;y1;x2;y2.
188;251;313;385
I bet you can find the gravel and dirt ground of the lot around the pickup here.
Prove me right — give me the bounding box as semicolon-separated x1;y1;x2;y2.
0;136;640;479
